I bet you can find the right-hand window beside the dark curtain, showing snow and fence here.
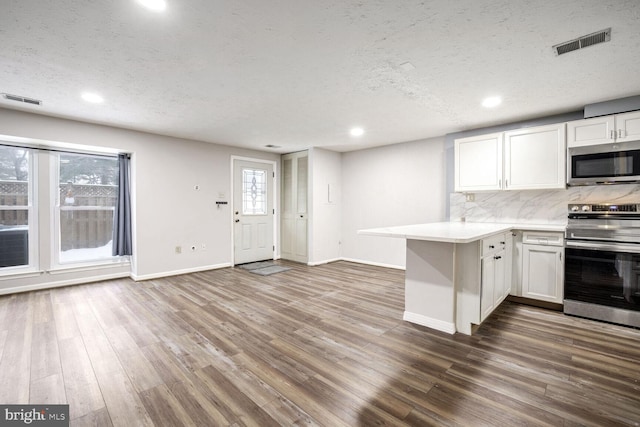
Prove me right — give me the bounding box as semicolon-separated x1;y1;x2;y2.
56;153;118;264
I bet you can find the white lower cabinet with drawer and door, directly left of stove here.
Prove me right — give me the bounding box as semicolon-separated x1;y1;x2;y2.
522;232;564;304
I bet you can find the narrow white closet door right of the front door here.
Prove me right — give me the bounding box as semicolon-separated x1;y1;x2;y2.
281;151;309;263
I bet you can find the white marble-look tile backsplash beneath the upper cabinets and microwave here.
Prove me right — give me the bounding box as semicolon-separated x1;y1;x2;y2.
449;184;640;224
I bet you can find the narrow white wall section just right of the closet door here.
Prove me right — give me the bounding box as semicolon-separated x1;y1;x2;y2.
309;148;342;265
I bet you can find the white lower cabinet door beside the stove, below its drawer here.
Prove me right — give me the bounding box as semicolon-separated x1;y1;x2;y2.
522;245;563;304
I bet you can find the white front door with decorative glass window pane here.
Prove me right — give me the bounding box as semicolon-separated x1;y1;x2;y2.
233;159;274;264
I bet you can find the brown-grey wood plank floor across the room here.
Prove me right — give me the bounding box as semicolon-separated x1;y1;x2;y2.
0;262;640;426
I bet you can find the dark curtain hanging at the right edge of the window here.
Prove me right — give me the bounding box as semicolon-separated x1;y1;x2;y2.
113;154;133;256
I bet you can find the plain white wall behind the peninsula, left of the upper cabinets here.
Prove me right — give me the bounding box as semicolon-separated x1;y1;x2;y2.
342;138;446;268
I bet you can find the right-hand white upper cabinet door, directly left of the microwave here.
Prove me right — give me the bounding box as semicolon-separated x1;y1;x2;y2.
504;123;566;190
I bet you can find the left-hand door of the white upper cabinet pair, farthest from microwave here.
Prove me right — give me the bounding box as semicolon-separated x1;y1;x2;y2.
454;133;502;191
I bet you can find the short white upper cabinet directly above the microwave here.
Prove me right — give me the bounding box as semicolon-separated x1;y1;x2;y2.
567;111;640;148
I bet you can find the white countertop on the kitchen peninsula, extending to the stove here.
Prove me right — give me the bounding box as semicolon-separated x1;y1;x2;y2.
358;222;565;243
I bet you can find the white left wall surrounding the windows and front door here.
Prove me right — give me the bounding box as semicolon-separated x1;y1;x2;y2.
0;109;280;289
